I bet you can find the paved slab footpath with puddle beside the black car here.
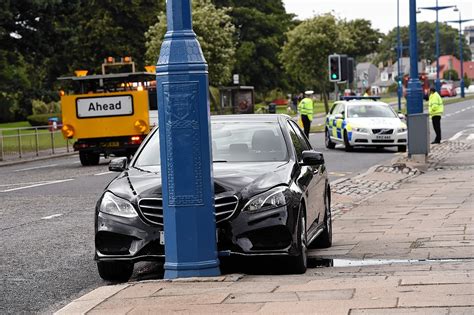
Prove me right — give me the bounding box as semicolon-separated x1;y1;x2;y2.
58;130;474;315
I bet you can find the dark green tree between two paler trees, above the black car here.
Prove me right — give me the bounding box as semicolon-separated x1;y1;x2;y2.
214;0;293;94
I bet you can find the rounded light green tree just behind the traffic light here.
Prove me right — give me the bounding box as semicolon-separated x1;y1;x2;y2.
280;14;344;112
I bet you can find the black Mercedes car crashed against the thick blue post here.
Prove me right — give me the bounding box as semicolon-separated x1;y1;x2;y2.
95;115;332;281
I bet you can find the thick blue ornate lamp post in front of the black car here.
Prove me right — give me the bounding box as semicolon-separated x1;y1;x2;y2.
156;0;220;279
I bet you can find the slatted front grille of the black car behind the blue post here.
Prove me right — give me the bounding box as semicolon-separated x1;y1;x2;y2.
138;196;239;226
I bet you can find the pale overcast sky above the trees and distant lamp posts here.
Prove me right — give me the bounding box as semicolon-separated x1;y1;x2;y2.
283;0;474;33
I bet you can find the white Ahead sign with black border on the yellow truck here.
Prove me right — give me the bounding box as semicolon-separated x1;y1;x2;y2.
76;95;133;118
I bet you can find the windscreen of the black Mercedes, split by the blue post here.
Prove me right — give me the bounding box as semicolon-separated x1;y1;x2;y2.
134;121;288;167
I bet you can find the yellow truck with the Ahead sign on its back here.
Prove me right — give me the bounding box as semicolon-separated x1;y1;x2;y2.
58;66;158;166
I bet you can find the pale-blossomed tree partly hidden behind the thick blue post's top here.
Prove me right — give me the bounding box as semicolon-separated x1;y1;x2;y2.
145;0;235;86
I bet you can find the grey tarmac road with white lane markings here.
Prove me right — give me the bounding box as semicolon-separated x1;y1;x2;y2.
0;97;474;314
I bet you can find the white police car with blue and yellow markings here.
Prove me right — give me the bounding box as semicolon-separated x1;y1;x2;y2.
325;97;407;152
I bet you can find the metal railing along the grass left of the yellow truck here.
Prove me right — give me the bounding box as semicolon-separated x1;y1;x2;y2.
0;125;71;161
